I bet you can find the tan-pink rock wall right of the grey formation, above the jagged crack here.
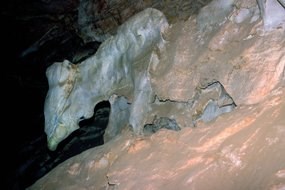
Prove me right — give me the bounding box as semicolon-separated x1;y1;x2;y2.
151;0;285;105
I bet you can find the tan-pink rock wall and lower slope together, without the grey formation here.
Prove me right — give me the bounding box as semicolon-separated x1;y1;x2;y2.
28;1;285;190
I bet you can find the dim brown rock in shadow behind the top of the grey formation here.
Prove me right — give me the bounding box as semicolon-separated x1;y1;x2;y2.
78;0;210;42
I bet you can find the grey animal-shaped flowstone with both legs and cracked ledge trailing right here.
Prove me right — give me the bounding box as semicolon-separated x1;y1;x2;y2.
44;8;235;150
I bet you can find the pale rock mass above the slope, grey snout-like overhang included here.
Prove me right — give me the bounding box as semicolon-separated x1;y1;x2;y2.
45;0;285;153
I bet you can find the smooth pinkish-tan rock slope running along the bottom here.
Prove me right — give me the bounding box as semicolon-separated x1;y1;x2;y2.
28;87;285;190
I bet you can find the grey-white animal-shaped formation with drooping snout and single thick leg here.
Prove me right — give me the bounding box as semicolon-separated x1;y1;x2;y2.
44;8;168;150
